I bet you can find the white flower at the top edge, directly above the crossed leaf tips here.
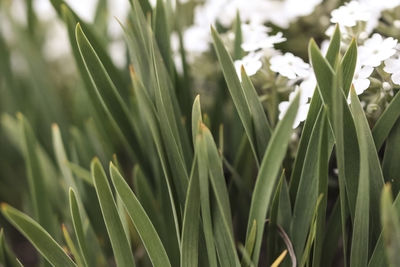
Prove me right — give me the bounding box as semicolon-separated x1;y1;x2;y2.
331;1;372;27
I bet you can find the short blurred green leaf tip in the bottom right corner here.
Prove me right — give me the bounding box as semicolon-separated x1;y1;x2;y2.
381;185;400;267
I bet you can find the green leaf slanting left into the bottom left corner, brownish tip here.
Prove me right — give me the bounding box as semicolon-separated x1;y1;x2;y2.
1;203;76;267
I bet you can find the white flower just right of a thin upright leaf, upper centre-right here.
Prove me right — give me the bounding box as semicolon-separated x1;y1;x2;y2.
242;24;286;52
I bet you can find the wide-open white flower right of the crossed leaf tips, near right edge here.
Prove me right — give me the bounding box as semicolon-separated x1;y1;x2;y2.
358;33;397;67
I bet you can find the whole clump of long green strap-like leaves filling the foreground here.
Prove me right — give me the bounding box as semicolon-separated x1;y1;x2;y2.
0;0;400;267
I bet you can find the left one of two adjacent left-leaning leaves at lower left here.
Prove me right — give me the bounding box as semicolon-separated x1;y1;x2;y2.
90;158;135;267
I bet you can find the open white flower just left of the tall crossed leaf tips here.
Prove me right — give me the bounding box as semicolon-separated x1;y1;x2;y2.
270;53;310;79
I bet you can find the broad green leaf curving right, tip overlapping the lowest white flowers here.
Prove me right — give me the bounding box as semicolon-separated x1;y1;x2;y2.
247;90;300;265
